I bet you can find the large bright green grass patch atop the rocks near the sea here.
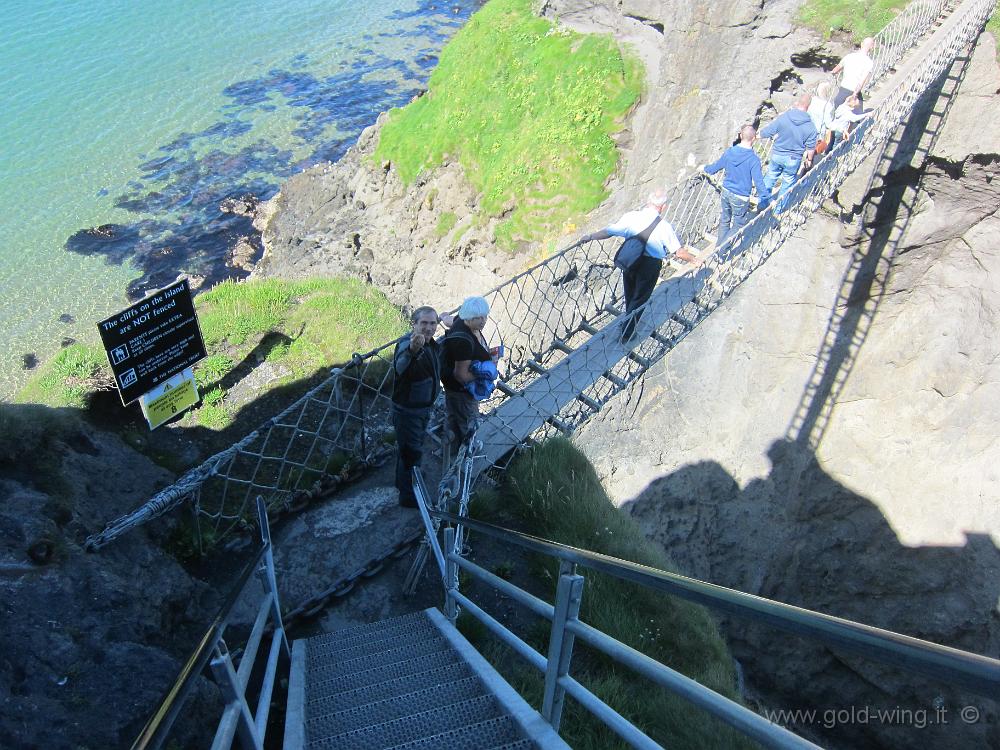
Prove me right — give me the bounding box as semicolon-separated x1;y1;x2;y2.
375;0;642;247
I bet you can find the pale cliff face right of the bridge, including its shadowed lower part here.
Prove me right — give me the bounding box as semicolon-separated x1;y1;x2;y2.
576;34;1000;748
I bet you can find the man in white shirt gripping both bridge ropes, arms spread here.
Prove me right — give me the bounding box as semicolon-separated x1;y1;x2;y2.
577;189;697;341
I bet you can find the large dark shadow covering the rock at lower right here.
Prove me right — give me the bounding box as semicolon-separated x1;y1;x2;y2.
623;440;1000;749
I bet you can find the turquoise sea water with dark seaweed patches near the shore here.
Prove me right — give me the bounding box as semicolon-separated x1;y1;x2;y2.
0;0;481;397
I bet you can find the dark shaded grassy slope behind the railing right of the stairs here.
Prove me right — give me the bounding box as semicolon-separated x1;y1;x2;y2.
465;438;754;750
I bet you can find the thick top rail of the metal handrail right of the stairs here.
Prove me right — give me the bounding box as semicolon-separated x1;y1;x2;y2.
431;511;1000;698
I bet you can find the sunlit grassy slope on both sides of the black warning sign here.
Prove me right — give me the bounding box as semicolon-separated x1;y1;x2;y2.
16;279;405;429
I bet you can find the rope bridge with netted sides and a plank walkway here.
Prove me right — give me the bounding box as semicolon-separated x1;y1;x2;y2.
87;0;994;550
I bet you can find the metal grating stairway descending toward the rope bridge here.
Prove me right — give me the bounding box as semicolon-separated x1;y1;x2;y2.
284;608;568;750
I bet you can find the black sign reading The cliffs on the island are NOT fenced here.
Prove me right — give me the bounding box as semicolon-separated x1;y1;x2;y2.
97;279;206;405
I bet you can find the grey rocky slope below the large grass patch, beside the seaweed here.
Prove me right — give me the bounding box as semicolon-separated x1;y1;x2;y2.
256;114;526;309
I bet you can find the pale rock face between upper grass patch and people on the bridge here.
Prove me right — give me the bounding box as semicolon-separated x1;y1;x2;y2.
542;0;819;194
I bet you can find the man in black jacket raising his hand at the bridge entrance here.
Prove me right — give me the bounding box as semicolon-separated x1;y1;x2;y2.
392;307;441;508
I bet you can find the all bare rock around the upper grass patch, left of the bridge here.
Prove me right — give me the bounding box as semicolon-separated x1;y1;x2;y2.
256;0;816;308
